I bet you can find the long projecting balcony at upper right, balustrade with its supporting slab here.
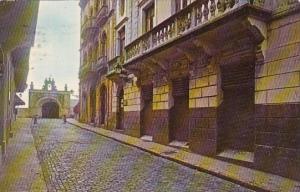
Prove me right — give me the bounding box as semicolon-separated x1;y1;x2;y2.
125;0;270;65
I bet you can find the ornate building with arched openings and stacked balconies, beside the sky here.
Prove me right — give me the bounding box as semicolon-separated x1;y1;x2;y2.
79;0;115;125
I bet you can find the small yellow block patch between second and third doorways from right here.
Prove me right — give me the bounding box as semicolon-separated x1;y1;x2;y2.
152;85;170;110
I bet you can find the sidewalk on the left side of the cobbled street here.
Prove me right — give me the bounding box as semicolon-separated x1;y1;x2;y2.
0;119;47;192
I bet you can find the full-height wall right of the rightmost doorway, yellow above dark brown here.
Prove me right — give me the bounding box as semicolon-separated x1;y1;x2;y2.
255;14;300;179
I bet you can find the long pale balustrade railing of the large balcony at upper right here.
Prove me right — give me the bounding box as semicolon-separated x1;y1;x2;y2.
125;0;258;62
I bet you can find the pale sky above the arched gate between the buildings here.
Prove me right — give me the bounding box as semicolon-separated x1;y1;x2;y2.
21;0;80;107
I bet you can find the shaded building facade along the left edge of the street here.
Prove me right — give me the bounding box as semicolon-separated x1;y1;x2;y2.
0;0;39;156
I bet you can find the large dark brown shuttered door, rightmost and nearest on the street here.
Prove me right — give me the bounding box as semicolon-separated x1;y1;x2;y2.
221;64;254;151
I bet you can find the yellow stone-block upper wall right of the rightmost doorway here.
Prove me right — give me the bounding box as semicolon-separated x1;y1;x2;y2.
255;14;300;104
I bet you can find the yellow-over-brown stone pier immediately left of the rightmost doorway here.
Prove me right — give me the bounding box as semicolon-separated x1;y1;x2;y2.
189;62;218;155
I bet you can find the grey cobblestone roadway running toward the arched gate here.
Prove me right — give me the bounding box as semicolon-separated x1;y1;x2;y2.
32;120;254;192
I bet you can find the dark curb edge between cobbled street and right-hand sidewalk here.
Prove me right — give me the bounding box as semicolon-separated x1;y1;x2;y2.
67;121;269;192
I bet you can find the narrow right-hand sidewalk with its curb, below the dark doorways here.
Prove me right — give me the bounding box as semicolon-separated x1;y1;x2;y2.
67;119;300;192
